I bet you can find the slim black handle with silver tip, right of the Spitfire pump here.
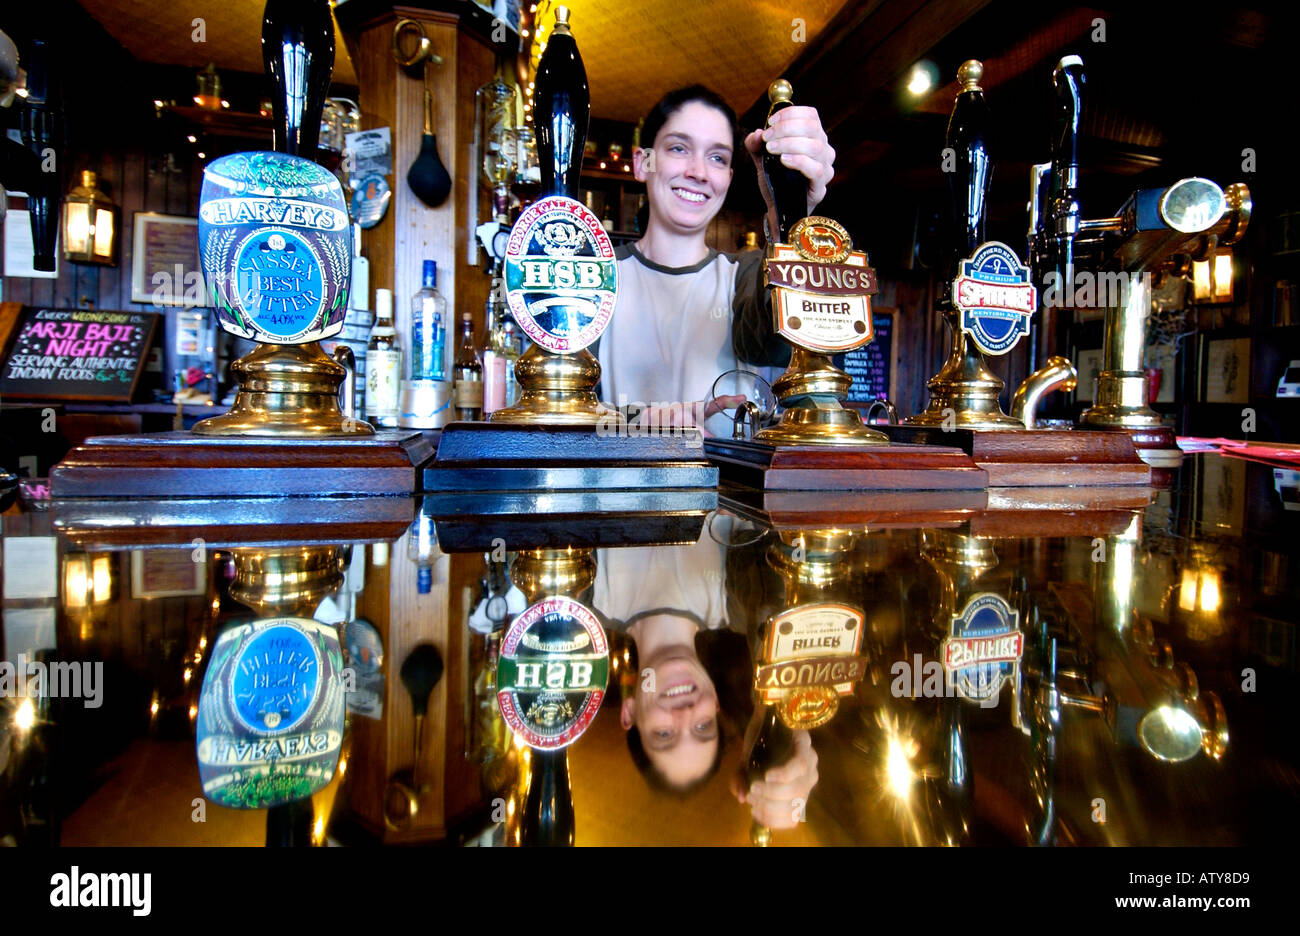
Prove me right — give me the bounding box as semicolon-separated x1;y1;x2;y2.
1045;56;1084;287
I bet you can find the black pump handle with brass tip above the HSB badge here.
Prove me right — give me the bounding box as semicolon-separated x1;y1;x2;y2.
533;7;592;199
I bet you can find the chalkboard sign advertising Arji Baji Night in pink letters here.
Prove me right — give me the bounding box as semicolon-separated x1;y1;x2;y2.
0;306;159;403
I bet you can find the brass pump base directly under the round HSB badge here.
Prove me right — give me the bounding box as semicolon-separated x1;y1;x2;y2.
488;345;610;426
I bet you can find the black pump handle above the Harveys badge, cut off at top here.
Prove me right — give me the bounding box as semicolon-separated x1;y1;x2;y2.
261;0;334;163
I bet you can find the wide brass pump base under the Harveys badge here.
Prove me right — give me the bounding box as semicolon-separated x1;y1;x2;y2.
192;342;374;438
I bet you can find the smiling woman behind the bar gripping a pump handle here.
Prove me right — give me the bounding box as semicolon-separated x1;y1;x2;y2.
597;85;835;436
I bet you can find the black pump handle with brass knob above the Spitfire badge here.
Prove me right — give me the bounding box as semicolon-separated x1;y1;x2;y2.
944;59;993;266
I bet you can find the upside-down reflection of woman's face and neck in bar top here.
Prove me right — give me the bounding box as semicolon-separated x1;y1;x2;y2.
621;615;719;787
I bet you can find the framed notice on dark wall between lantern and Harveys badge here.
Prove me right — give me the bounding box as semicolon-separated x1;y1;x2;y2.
131;212;208;307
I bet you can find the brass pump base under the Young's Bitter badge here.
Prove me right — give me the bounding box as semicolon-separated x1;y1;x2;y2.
754;347;889;446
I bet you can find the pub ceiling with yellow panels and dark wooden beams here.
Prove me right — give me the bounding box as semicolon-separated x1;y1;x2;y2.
55;0;1284;253
